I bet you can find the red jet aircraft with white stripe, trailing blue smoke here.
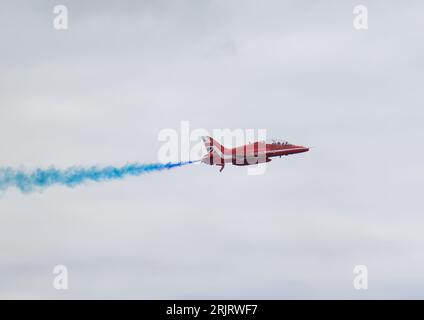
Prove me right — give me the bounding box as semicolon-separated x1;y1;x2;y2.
201;137;309;172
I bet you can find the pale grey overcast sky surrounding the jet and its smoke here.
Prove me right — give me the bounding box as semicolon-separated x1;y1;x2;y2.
0;0;424;299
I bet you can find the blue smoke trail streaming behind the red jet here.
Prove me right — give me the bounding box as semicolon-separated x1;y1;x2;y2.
0;161;196;192
